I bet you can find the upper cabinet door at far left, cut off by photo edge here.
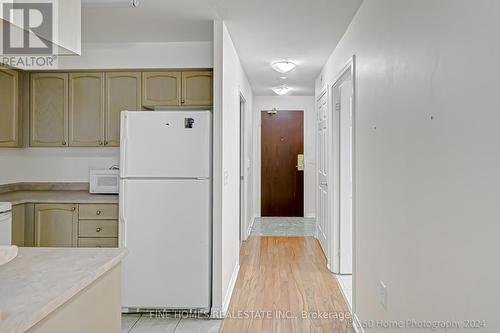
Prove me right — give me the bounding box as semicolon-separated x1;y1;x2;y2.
0;69;20;147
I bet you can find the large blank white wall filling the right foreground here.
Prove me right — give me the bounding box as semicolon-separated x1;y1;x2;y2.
316;0;500;332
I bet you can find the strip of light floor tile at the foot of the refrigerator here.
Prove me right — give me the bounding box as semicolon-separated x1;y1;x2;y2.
122;314;222;333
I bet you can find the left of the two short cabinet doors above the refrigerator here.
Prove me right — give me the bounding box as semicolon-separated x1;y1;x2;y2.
142;72;181;107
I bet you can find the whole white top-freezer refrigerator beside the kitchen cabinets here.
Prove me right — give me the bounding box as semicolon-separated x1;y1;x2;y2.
120;111;212;311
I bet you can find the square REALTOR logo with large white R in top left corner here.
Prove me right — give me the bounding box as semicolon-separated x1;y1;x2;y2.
2;3;53;55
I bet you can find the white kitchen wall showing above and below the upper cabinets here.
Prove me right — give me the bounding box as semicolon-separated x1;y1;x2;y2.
0;42;213;184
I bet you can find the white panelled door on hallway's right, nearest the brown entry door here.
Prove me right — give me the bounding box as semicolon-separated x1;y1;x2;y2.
316;92;330;261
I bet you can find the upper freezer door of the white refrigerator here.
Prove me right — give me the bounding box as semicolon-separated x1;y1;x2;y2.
120;111;212;178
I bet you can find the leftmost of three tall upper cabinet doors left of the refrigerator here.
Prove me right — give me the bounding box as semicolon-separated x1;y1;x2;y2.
30;73;68;147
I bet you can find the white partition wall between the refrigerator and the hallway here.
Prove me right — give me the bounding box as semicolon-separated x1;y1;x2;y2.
213;21;253;311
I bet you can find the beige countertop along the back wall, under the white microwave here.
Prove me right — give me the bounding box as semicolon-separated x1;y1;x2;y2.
0;190;118;206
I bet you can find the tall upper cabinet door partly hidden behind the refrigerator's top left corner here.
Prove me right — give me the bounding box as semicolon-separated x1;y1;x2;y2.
104;72;142;147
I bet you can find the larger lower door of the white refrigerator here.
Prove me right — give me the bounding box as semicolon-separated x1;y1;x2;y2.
120;180;211;309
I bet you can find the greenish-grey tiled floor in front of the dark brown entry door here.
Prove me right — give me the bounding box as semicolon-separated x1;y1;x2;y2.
251;217;316;237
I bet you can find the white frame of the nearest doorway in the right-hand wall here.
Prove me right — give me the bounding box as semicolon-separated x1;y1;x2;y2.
328;55;357;313
